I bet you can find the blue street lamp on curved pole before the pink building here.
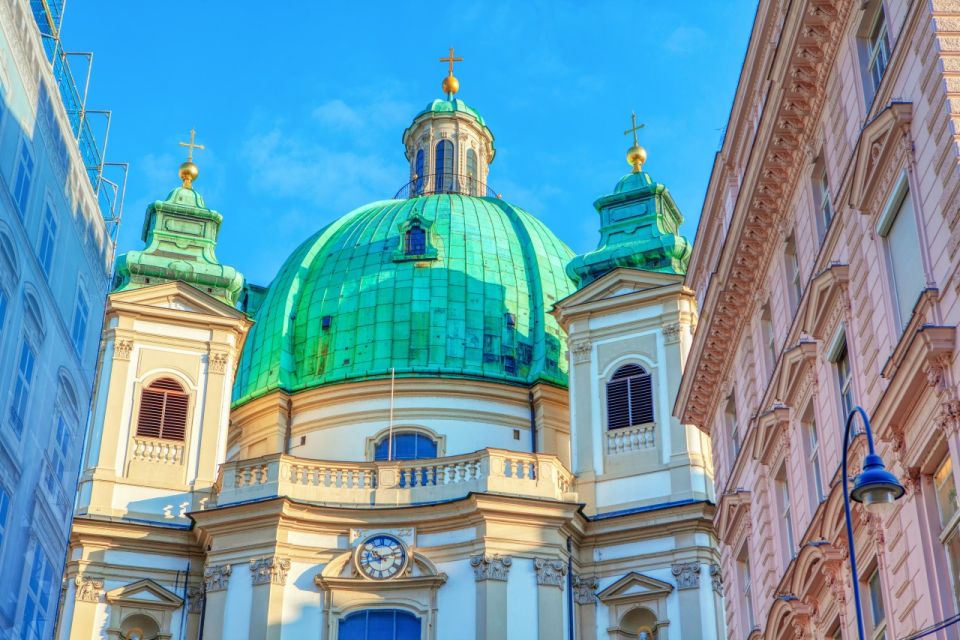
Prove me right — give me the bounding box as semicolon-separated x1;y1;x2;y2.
840;406;904;640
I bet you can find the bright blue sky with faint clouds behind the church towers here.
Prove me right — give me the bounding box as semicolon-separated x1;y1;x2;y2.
62;0;756;284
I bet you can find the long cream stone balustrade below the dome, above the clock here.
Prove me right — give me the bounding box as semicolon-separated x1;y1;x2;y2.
216;449;577;507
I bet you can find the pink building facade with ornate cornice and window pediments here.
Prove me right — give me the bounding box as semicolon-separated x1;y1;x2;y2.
675;0;960;640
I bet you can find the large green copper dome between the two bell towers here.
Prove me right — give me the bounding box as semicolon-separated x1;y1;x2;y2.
234;194;575;404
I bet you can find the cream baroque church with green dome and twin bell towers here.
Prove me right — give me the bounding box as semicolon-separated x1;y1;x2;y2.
57;60;726;640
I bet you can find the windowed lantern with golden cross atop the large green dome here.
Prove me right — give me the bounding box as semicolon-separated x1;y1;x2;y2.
403;48;496;198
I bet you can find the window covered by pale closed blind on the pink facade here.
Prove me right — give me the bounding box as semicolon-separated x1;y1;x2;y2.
877;178;926;331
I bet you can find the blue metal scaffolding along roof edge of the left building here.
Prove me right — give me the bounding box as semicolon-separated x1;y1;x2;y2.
30;0;128;244
